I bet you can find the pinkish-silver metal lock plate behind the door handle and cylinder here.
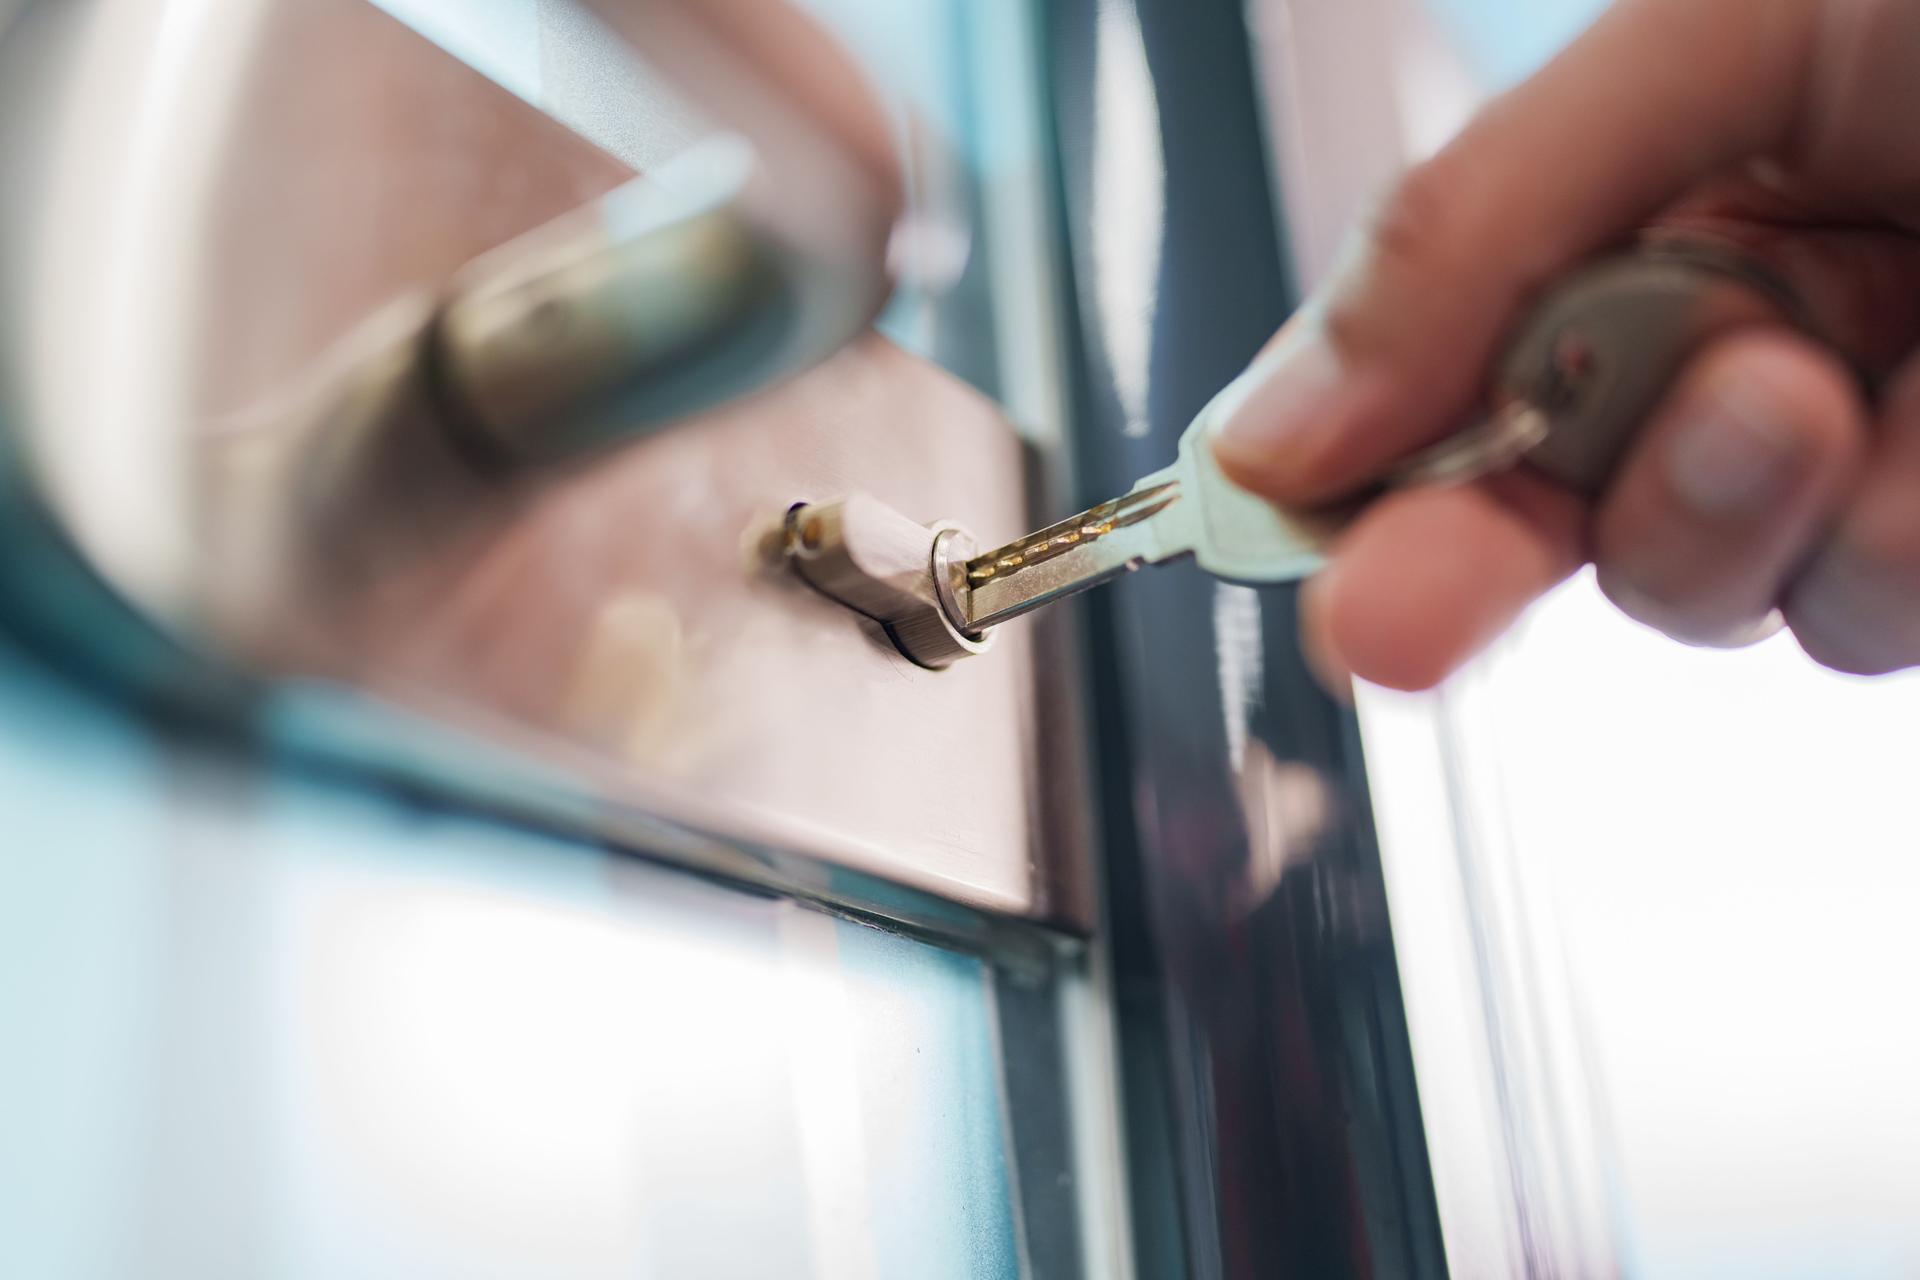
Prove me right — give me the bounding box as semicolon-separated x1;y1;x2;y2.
0;0;1091;929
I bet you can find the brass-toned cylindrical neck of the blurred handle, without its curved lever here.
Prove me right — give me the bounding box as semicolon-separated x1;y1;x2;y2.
432;134;889;464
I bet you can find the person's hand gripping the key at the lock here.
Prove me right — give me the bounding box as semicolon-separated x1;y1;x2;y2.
1215;0;1920;689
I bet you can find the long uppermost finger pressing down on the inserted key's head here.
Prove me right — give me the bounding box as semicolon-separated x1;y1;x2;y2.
1213;0;1822;503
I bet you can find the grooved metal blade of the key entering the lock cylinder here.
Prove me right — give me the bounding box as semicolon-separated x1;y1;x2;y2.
964;468;1190;631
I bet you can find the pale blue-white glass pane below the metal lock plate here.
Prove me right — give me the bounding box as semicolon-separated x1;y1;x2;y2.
0;625;1018;1280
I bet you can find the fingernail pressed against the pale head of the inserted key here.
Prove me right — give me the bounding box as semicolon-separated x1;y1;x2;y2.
1213;320;1346;472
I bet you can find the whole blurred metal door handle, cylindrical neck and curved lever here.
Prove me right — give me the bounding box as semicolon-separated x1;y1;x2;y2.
332;0;904;466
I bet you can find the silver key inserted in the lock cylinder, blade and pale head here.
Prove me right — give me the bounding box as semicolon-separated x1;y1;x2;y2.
956;387;1342;631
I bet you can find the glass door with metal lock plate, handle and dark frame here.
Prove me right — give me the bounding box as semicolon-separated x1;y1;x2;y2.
0;0;1566;1276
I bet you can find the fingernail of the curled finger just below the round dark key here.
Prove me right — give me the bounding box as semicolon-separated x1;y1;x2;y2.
1667;386;1807;520
